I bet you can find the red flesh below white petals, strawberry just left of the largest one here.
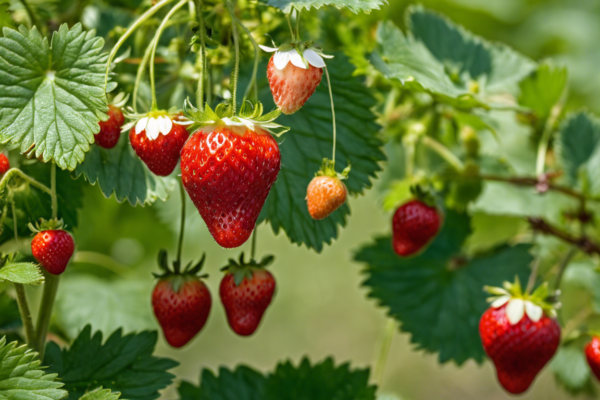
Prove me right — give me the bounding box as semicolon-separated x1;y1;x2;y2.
129;119;190;176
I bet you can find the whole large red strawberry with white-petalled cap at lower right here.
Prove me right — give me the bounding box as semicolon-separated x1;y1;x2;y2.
479;284;560;394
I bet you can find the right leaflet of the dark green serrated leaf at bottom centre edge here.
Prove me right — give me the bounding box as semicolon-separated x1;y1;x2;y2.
265;358;376;400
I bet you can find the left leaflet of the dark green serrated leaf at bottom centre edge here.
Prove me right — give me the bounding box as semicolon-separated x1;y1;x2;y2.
179;366;267;400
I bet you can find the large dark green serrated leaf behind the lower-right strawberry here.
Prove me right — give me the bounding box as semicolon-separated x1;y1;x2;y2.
355;211;532;365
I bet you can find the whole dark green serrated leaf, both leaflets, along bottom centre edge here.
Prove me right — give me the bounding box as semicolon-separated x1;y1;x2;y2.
179;358;376;400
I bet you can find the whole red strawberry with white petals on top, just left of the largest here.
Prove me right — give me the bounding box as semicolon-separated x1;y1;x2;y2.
129;112;189;176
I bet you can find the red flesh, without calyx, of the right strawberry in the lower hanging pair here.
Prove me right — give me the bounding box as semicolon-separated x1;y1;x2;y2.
219;269;275;336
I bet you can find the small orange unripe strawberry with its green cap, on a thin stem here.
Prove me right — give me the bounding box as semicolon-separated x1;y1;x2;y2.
306;158;350;220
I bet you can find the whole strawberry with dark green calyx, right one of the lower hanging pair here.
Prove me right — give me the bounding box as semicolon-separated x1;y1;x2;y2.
219;254;275;336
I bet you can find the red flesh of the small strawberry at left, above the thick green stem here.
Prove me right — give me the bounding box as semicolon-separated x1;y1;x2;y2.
31;229;75;275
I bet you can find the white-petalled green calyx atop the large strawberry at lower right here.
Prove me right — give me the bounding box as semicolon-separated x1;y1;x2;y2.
484;278;559;325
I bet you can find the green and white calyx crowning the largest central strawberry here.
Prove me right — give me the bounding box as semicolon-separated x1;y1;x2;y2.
181;99;290;136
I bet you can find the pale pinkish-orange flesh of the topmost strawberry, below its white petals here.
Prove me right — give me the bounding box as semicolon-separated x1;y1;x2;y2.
267;56;323;114
